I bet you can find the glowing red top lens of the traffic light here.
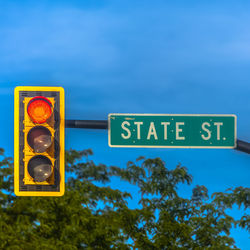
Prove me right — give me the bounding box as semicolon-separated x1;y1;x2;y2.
27;96;52;123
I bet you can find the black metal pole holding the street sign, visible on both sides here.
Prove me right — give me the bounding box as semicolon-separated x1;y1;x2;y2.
65;120;250;154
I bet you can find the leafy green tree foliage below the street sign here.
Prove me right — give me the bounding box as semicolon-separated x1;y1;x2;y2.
0;149;250;250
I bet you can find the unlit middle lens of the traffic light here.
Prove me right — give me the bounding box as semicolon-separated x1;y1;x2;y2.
27;126;52;153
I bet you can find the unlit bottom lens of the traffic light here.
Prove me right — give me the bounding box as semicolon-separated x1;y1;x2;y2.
28;155;52;182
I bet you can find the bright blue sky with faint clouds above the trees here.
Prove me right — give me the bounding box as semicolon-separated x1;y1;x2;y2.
0;0;250;249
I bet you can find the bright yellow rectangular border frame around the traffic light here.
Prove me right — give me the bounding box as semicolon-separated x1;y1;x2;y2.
14;86;65;196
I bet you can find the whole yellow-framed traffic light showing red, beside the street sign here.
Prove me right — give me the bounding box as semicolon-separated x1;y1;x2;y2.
14;86;65;196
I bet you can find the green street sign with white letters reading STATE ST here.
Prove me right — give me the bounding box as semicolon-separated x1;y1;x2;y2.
108;114;236;148
